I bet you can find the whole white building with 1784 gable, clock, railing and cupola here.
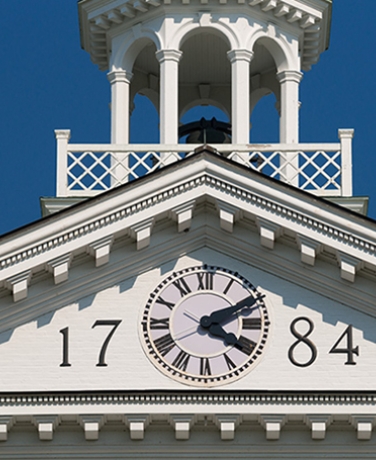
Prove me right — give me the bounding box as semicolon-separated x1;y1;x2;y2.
0;0;376;459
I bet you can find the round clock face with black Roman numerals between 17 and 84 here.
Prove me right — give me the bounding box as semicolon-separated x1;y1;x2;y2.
141;265;269;386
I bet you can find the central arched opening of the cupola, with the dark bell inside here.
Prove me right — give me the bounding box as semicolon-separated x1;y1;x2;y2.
179;28;231;143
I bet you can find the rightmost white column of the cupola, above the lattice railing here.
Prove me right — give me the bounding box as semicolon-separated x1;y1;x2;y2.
277;70;303;144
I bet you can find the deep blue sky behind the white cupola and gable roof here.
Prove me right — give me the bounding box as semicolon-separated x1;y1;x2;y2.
0;0;376;234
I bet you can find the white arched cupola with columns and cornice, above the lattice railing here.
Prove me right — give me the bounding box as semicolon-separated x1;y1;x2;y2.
79;0;332;144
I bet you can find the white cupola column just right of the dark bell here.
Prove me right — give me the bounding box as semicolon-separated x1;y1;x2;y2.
227;50;253;144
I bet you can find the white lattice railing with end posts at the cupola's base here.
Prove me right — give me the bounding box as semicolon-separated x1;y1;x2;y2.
55;129;354;197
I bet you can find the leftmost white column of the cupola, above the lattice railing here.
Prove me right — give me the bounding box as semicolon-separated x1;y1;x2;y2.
107;70;132;144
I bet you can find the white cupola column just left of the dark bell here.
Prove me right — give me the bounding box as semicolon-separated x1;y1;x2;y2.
155;49;183;144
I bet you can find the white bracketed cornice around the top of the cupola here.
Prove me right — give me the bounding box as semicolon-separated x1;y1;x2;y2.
79;0;331;70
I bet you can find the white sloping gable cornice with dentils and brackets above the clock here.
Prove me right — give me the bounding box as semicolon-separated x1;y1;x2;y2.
0;148;376;324
